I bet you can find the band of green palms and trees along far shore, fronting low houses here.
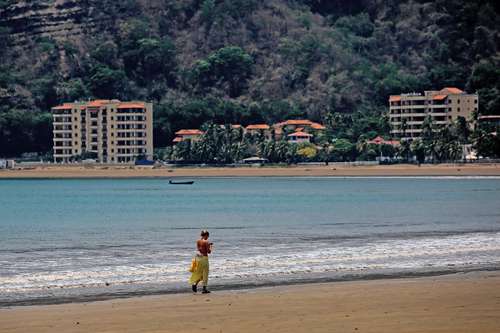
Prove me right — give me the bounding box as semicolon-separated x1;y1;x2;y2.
155;117;500;164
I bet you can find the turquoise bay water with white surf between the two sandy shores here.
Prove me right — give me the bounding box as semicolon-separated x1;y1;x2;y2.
0;177;500;306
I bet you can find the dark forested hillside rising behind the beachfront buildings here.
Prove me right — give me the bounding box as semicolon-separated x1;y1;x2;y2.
0;0;500;156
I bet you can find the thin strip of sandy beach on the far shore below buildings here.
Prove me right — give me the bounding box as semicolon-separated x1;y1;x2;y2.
0;164;500;179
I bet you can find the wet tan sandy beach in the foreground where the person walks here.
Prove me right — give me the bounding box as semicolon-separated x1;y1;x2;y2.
0;272;500;333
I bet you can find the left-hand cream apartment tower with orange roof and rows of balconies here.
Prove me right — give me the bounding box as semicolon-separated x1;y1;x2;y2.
52;99;153;163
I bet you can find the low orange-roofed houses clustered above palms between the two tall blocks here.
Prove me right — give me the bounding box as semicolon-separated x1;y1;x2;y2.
173;119;326;144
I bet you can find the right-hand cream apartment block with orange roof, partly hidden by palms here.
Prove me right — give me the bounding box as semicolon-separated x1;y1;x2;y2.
389;87;479;139
